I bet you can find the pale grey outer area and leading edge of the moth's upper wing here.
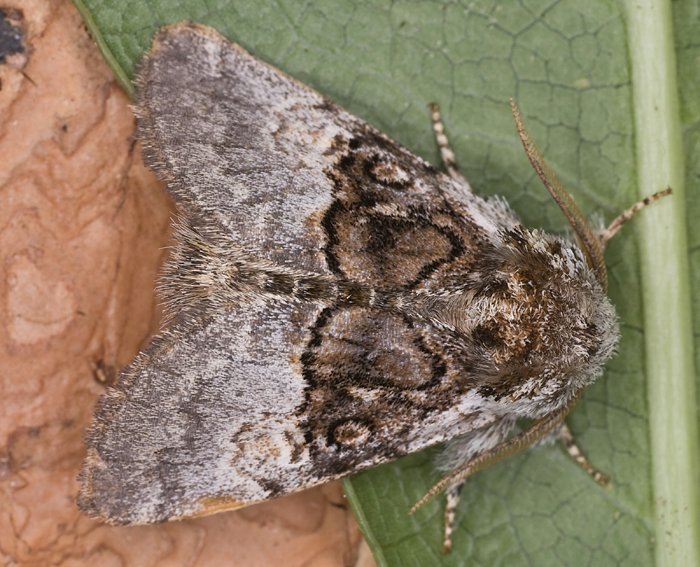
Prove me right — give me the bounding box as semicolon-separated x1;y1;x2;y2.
136;23;516;272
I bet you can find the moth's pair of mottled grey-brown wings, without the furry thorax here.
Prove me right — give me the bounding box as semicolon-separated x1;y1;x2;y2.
79;24;516;523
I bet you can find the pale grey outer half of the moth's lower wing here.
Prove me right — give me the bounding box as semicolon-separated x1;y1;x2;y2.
79;303;320;524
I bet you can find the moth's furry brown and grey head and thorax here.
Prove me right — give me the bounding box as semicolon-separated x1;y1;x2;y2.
453;226;619;417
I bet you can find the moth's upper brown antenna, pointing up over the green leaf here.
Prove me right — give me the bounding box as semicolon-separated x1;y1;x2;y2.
510;97;608;291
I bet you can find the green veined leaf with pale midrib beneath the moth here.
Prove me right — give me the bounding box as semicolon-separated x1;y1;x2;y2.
76;0;700;566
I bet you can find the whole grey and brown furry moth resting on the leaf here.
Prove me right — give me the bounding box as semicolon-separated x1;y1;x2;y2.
78;23;668;547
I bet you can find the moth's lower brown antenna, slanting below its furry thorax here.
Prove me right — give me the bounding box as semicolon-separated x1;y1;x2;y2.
409;394;580;514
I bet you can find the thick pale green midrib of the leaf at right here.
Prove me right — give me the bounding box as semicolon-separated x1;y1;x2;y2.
625;0;700;567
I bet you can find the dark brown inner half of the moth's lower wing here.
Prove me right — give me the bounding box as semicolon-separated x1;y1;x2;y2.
301;307;491;478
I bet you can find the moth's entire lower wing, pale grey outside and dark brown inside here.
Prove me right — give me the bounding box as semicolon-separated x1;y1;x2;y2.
78;302;490;524
